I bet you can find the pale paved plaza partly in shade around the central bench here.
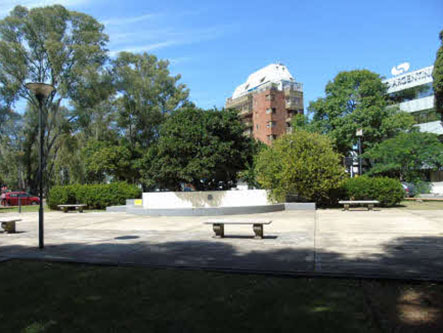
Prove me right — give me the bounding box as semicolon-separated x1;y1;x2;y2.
0;209;443;280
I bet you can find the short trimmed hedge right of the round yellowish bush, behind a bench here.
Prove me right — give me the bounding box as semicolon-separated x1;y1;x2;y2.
343;176;405;206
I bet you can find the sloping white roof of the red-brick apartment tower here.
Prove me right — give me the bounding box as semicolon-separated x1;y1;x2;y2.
232;64;294;98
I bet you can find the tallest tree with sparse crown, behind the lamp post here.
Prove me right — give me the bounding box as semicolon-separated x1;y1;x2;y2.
0;5;108;192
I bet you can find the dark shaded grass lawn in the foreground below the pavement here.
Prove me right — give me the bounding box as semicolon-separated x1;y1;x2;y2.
0;261;443;333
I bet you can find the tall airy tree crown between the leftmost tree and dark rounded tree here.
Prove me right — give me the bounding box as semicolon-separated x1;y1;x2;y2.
112;52;189;149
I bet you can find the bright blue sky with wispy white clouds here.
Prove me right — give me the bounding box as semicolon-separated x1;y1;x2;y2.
0;0;443;108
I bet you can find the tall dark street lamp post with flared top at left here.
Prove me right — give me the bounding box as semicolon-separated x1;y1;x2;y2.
26;82;55;249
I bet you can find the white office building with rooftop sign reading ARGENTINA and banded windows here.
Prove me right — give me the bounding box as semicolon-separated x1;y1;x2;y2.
384;64;443;137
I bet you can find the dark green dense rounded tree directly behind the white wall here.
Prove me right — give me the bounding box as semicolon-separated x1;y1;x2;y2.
140;106;253;190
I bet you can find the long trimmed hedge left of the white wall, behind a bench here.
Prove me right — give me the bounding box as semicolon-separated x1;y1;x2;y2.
48;182;141;209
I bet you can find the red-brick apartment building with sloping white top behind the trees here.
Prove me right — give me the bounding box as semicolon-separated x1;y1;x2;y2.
226;64;303;145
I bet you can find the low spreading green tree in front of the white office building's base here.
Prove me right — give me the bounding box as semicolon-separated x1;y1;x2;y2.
364;132;443;182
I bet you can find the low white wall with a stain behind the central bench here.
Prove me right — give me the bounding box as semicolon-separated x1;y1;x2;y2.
143;190;271;209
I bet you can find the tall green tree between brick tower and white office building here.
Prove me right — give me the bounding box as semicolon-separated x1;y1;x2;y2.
308;70;414;154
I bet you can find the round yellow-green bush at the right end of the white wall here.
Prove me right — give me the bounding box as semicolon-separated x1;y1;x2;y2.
256;130;345;203
